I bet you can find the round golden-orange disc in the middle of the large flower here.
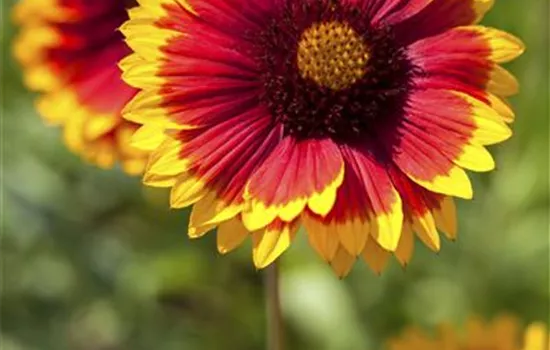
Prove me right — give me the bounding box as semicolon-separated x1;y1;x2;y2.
297;21;369;91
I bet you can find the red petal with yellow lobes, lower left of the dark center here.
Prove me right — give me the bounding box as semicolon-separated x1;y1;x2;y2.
161;107;280;219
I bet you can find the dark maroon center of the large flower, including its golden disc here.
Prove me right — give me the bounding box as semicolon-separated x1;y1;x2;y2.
253;0;415;142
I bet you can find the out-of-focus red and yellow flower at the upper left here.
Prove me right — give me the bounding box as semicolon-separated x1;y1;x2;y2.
14;0;147;174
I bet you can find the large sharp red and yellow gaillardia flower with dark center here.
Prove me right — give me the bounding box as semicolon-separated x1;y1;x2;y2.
121;0;523;276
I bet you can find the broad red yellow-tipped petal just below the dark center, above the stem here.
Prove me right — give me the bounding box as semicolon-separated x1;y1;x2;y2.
243;137;344;231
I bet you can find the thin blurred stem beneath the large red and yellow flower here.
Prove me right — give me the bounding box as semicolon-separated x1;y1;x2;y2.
265;262;284;350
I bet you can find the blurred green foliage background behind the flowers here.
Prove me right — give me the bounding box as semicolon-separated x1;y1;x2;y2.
0;0;550;350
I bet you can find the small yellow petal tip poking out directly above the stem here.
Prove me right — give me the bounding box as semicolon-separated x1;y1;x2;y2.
252;220;299;269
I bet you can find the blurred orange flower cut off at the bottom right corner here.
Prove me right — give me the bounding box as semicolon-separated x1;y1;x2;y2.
387;316;550;350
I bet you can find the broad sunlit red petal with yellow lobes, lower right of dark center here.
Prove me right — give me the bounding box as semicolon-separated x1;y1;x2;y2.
392;90;511;198
